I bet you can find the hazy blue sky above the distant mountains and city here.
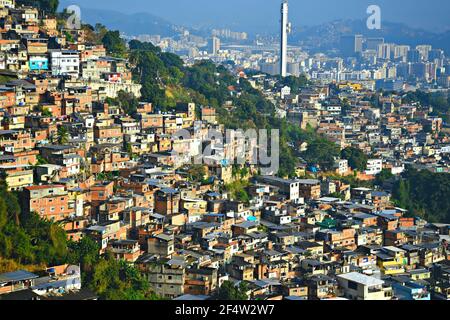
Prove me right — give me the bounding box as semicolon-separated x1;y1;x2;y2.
61;0;450;31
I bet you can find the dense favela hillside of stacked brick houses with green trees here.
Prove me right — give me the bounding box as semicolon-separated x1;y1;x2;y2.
0;0;450;300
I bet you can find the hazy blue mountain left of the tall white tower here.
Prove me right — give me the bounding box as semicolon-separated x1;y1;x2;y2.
74;7;179;37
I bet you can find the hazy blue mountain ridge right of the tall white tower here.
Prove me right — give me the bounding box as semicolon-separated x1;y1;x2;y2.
291;20;450;53
